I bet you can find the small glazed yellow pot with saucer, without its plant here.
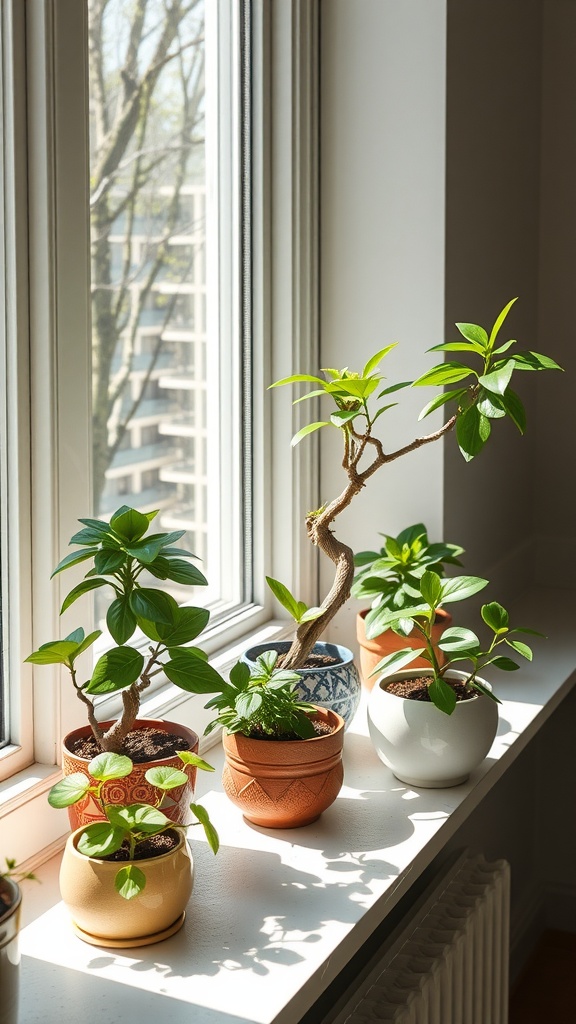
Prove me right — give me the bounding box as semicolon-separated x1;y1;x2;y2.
59;828;194;947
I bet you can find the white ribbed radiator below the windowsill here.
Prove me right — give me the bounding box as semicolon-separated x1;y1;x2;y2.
333;854;509;1024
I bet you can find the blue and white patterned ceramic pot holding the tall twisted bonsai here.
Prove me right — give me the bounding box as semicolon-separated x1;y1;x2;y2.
242;640;361;728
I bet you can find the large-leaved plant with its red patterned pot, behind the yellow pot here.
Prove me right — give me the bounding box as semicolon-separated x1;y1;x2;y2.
27;506;226;827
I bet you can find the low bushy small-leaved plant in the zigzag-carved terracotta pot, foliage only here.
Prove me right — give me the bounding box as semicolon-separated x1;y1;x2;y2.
195;650;317;739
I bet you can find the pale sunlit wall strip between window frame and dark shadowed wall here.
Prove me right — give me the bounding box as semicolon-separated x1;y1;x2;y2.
321;0;446;643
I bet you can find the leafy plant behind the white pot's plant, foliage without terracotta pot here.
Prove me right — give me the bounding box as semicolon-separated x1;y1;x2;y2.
351;522;464;640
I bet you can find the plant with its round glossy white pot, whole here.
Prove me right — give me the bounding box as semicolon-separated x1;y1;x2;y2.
368;570;542;787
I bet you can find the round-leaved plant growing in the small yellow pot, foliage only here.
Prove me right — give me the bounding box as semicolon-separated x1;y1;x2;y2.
48;751;219;900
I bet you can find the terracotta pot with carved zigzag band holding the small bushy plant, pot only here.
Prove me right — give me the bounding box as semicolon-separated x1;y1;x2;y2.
222;708;344;828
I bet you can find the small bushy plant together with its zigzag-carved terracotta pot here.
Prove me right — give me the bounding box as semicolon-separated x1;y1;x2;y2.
188;650;344;828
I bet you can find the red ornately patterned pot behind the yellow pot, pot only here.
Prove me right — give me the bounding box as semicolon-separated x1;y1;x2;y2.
63;719;199;829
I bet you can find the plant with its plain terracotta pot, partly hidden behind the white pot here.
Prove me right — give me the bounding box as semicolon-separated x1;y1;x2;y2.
351;522;464;689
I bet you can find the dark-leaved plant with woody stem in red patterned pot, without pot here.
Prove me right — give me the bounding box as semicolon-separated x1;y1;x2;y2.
26;505;222;754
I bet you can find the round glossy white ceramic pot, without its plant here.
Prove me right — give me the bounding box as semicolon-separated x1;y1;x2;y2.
368;669;498;788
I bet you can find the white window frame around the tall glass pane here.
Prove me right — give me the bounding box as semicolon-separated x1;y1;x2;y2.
0;0;320;872
